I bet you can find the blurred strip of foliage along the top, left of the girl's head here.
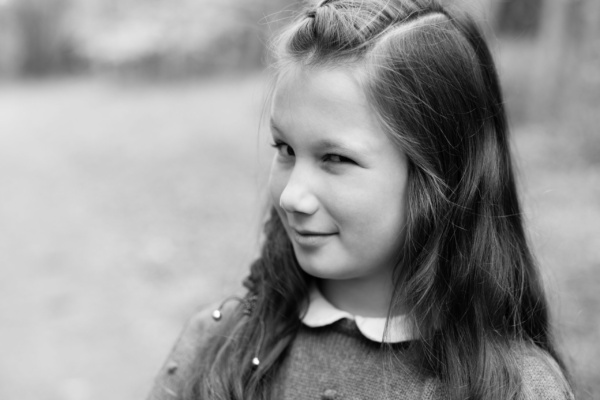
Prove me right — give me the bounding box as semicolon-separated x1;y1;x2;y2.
0;0;292;78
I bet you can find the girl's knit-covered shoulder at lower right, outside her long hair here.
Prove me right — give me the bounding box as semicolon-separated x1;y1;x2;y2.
516;345;575;400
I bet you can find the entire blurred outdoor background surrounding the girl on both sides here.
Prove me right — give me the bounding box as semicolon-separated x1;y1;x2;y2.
0;0;600;400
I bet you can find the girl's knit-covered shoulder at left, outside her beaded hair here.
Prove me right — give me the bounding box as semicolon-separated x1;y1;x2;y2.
147;302;238;400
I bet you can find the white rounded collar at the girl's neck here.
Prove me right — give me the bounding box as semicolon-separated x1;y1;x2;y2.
302;285;413;343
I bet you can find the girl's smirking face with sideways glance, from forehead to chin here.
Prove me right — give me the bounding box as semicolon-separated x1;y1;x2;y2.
269;68;407;285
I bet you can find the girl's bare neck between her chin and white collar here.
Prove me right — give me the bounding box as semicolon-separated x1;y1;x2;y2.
317;276;394;318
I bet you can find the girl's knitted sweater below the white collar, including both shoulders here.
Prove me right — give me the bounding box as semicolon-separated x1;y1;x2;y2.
148;306;573;400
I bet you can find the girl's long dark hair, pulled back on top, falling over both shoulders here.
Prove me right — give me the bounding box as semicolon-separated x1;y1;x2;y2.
187;0;566;400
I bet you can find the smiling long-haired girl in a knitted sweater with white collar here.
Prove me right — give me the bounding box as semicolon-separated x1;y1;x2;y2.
145;0;573;400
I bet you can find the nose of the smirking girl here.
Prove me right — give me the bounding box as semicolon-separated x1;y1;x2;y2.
279;170;319;215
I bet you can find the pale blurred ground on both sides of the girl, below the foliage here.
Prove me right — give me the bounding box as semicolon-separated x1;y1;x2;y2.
0;75;600;400
